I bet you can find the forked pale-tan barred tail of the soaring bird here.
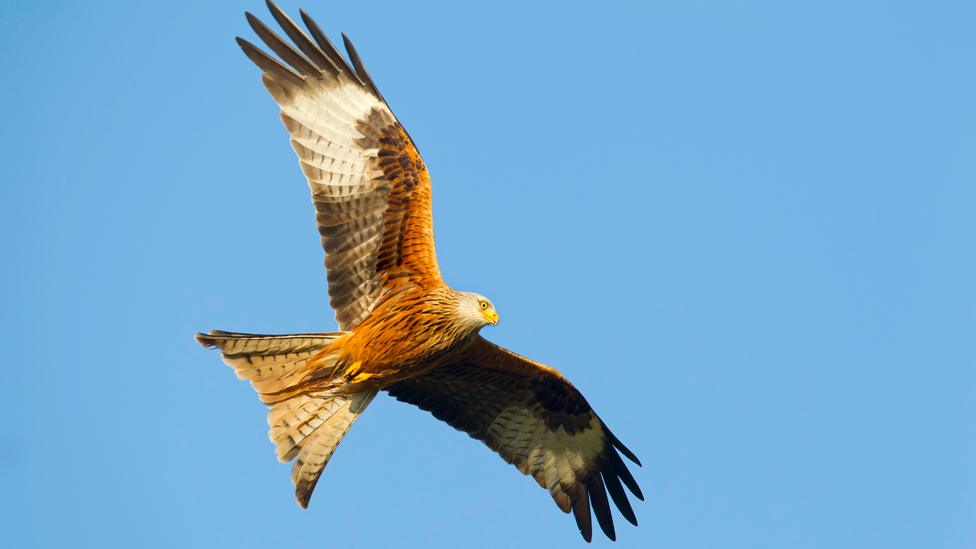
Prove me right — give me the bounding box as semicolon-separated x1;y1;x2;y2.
196;330;376;507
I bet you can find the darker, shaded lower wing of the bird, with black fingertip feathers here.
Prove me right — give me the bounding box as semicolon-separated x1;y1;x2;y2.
386;337;644;541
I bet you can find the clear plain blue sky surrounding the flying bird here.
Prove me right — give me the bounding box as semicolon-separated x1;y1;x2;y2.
0;0;976;548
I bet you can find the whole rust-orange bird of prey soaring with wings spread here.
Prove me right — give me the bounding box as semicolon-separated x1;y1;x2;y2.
196;1;643;541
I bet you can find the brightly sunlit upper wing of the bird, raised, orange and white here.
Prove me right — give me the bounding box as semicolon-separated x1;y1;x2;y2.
237;1;442;330
